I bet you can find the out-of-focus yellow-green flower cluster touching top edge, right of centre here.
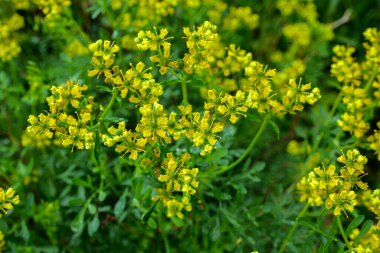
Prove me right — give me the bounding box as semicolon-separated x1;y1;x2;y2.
271;0;333;89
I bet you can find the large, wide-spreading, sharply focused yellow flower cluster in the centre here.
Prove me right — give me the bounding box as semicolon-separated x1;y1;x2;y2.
27;21;320;218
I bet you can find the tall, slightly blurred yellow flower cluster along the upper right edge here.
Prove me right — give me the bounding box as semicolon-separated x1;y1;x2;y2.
331;28;380;138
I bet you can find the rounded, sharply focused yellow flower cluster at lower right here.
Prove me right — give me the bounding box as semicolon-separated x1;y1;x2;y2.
297;149;368;215
